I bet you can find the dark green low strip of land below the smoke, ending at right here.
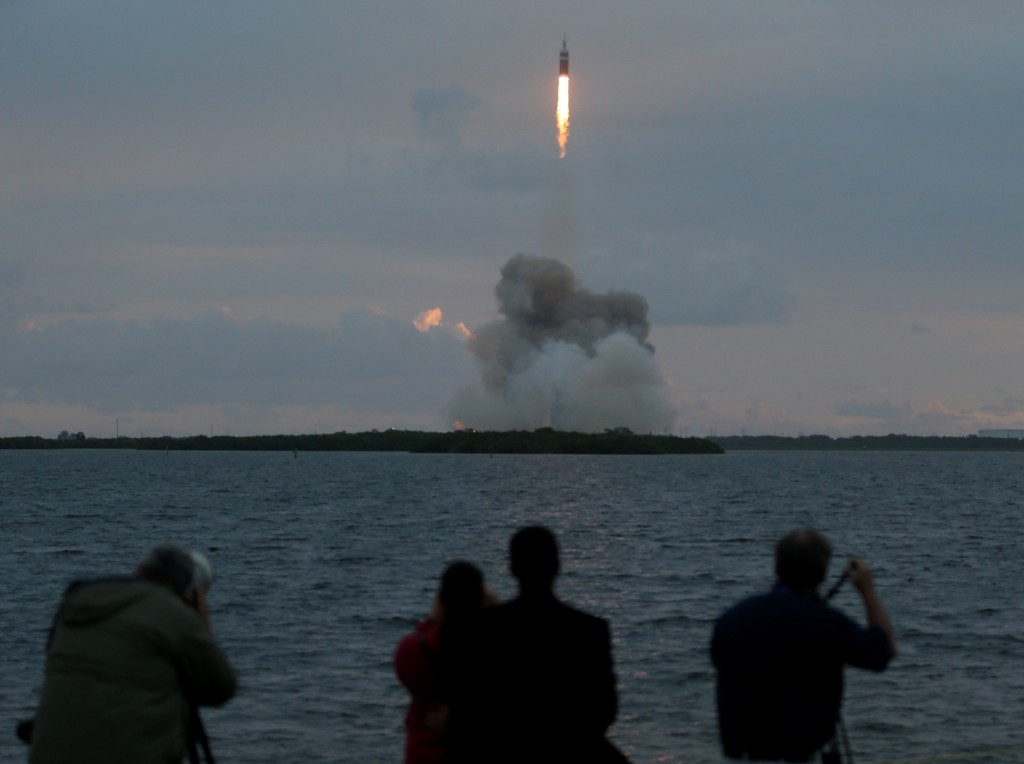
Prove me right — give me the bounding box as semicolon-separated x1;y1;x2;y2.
0;427;724;456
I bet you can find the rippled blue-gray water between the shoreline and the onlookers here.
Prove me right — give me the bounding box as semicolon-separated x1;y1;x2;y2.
0;451;1024;764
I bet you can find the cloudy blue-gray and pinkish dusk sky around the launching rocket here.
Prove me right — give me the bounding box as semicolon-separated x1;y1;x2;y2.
0;0;1024;437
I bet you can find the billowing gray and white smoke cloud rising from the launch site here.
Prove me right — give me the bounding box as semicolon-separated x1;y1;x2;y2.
449;254;675;433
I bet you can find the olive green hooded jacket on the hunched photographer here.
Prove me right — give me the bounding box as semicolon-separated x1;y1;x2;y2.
29;579;236;764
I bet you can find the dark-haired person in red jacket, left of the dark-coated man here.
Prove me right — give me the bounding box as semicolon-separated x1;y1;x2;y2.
394;560;496;764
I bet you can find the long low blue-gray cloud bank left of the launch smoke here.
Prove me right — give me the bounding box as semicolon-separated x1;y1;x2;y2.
0;309;471;416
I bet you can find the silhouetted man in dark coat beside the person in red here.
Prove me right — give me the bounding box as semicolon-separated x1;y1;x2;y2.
450;526;624;764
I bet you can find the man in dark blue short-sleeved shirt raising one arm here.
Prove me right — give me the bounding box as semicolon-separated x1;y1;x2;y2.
711;528;896;762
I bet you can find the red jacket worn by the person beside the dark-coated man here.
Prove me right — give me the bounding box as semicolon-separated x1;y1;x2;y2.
394;619;444;764
